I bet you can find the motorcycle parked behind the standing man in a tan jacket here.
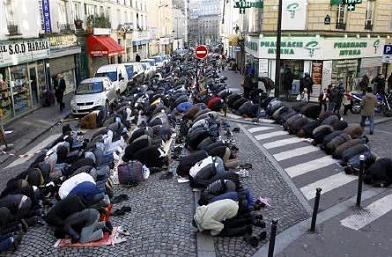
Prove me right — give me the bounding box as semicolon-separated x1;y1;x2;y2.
351;92;392;117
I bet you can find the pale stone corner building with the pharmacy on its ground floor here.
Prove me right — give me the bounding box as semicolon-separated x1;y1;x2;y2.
225;0;392;96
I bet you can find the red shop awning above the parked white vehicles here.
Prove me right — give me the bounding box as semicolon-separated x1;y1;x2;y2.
87;35;124;56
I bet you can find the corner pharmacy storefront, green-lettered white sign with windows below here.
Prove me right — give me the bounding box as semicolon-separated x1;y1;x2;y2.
258;36;385;97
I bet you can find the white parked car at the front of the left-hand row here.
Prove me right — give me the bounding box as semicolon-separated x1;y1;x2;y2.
71;77;117;115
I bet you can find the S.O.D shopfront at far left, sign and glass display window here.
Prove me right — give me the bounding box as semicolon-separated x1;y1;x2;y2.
0;39;50;122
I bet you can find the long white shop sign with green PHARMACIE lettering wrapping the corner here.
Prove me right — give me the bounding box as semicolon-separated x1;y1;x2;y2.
259;37;385;60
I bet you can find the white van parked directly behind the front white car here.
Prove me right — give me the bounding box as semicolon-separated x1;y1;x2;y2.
94;64;128;94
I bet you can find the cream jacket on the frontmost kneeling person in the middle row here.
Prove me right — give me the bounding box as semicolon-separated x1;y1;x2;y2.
194;199;239;236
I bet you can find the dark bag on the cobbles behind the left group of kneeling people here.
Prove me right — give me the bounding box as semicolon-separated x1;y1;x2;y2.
117;161;144;185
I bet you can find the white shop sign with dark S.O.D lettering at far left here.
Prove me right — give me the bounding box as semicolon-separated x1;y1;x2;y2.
0;39;50;67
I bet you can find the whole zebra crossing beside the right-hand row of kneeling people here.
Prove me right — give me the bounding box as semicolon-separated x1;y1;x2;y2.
248;125;366;209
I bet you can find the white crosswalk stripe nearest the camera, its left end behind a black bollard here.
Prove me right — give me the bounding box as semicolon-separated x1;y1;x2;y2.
301;172;357;200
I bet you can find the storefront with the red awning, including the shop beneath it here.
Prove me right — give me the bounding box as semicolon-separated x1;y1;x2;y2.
87;29;125;74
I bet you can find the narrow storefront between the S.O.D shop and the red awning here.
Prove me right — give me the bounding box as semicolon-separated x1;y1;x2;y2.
49;34;81;94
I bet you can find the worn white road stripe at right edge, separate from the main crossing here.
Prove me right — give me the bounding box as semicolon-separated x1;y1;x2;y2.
340;194;392;230
